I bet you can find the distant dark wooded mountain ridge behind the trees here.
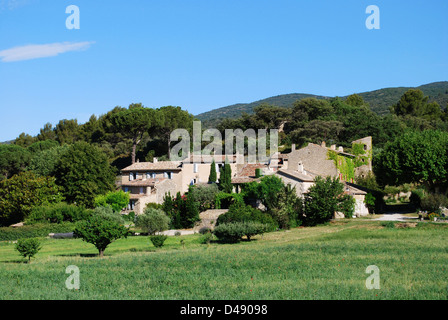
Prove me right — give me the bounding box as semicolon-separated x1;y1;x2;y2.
196;81;448;127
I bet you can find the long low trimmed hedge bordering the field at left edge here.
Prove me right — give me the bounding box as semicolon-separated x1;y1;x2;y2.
0;222;75;241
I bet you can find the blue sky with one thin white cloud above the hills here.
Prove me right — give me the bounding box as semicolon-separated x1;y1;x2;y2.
0;0;448;141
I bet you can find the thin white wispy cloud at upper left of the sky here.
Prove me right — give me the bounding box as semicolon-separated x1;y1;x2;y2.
0;41;95;62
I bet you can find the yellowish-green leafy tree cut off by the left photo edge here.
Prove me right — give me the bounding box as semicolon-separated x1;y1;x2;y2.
0;172;63;226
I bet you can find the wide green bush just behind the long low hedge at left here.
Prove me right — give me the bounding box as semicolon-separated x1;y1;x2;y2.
26;202;92;224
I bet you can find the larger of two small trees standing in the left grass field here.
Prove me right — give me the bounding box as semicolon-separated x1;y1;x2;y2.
73;215;129;257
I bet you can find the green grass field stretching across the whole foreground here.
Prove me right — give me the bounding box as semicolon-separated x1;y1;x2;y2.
0;219;448;300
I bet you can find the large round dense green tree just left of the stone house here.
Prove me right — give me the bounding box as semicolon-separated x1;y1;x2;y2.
55;142;115;208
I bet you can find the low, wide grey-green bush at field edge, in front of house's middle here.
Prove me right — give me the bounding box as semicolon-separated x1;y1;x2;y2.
213;221;269;243
